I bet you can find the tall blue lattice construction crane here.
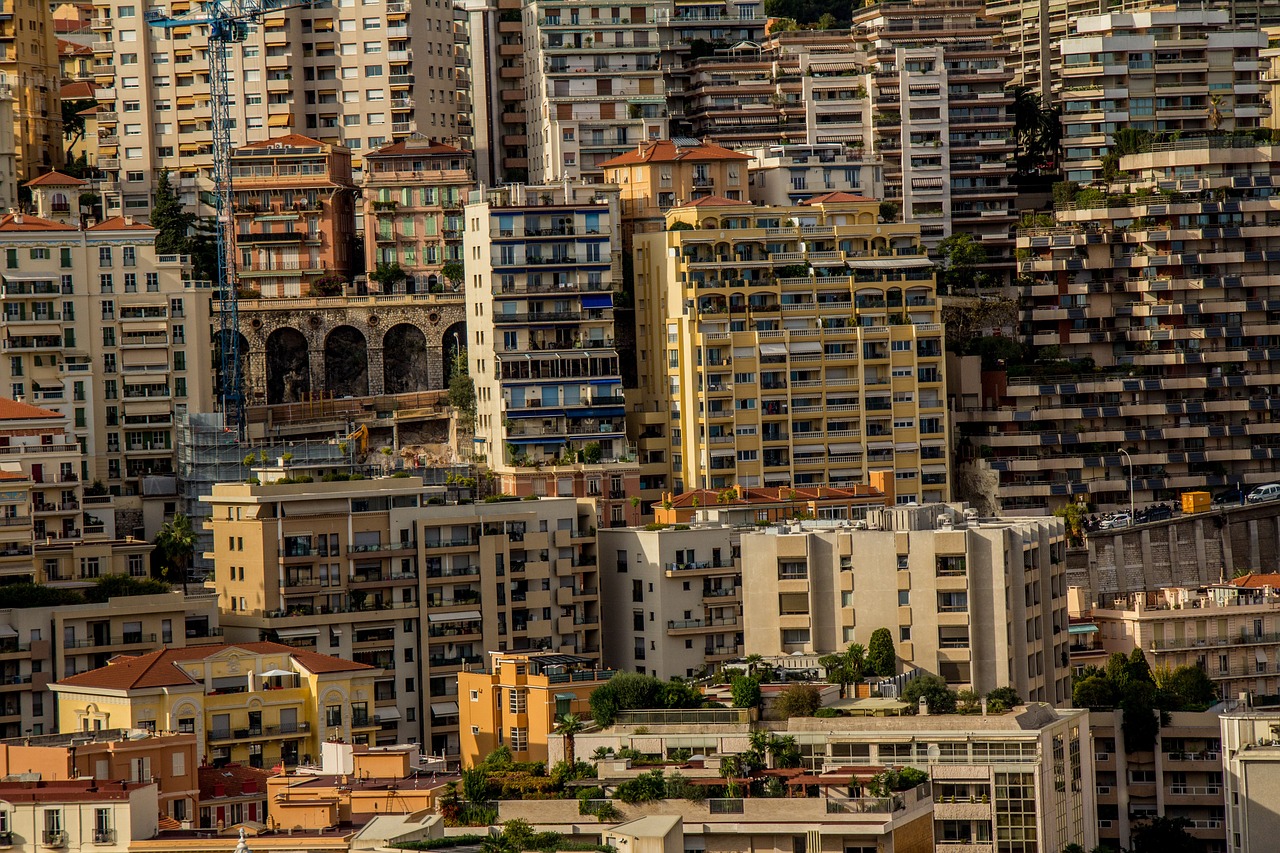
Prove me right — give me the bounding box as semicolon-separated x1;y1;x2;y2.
145;0;314;439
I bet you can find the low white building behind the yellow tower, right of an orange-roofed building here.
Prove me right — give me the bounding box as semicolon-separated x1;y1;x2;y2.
744;142;884;206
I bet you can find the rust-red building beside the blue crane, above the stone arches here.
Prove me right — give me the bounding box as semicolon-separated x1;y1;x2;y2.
232;133;364;298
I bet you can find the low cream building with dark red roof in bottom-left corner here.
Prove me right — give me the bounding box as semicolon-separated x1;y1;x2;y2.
0;779;160;853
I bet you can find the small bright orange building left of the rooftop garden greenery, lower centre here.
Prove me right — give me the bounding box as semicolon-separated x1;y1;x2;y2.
458;652;613;767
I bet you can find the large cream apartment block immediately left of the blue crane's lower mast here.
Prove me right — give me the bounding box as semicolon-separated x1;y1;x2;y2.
0;214;212;512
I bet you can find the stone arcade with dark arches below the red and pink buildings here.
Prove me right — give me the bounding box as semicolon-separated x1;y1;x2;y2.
232;293;466;406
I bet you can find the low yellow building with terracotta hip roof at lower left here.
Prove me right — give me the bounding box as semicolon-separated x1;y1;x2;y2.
50;643;378;767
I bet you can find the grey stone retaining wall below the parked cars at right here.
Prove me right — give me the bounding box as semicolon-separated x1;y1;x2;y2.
1066;502;1280;602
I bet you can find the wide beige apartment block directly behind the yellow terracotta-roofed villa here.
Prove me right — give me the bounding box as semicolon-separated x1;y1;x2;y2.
205;478;600;757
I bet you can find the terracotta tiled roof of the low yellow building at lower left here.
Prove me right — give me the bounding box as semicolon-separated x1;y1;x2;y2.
59;642;374;690
